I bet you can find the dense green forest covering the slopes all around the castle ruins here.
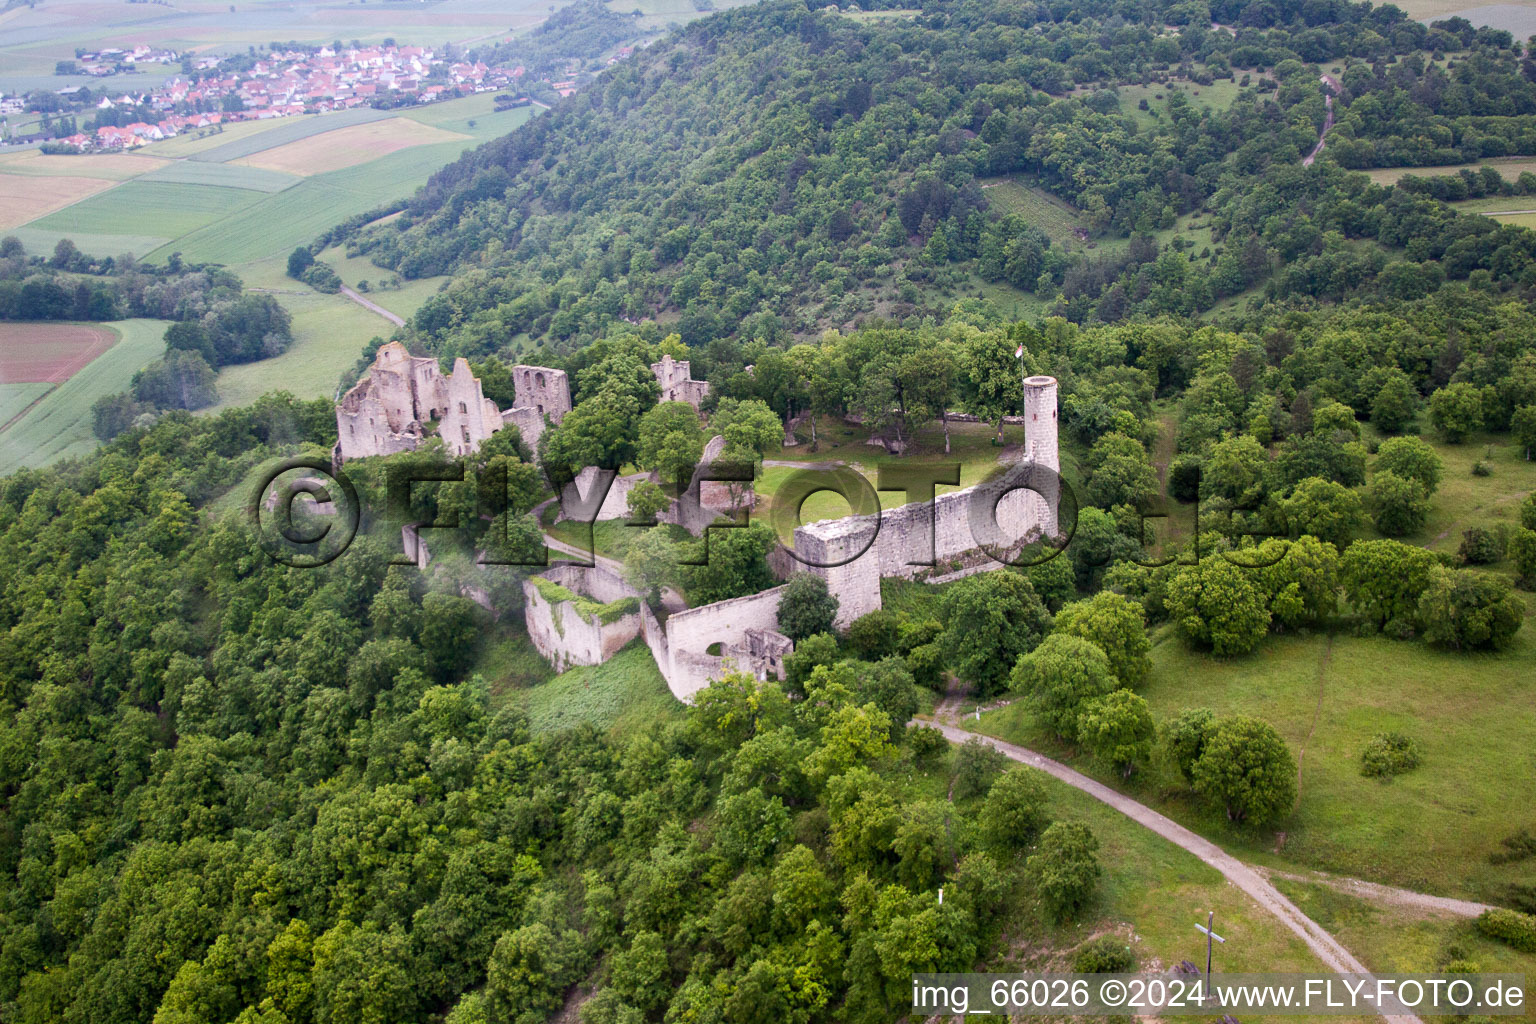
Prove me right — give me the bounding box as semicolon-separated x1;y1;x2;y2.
9;0;1536;1024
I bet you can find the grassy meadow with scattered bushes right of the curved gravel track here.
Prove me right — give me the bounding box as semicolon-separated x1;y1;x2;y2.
980;629;1536;900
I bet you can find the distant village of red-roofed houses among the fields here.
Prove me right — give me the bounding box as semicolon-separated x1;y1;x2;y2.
0;43;633;152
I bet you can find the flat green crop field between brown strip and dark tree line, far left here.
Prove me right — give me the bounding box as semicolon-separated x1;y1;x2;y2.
29;181;261;244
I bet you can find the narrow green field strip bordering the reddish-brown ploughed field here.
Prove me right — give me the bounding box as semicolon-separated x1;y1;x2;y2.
0;319;167;476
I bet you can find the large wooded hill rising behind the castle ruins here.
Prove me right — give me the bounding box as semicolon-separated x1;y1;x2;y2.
339;0;1536;363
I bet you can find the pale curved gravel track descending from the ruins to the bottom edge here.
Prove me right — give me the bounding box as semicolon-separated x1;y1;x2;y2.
929;722;1422;1024
